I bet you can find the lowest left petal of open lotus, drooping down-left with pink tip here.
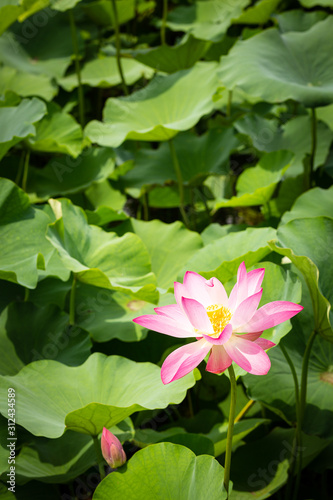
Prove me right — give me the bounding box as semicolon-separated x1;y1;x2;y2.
161;339;211;384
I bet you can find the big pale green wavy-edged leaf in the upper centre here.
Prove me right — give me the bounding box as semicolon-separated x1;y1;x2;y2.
85;62;218;147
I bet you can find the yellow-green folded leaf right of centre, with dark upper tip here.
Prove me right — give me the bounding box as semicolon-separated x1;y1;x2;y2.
215;150;293;209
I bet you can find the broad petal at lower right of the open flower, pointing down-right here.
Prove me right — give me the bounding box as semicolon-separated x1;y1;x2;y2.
223;335;271;375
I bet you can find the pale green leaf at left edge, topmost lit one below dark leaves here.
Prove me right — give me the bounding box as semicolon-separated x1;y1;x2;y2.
0;66;57;101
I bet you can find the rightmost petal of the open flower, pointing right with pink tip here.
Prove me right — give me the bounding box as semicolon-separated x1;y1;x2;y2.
242;300;303;333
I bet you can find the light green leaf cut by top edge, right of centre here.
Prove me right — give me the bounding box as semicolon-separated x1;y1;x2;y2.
167;0;250;42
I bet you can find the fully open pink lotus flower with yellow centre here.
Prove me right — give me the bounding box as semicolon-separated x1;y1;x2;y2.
133;262;303;384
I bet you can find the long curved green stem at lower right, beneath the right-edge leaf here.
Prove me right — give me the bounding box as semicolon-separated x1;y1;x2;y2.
293;330;317;500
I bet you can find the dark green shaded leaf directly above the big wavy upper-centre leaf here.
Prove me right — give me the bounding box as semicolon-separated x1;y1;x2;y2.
133;35;211;73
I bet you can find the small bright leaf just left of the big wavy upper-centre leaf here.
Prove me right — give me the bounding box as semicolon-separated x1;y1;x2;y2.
28;103;83;158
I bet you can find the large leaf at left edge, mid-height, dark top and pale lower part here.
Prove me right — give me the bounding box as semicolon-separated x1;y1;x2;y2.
0;179;70;288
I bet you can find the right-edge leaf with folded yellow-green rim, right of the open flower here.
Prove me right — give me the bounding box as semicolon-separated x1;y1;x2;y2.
271;217;333;342
